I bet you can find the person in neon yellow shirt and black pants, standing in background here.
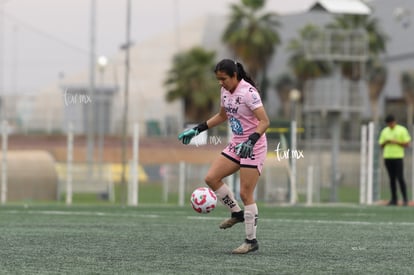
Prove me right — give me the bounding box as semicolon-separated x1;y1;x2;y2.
378;115;411;206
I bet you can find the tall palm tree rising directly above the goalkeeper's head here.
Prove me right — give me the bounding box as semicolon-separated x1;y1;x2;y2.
222;0;280;100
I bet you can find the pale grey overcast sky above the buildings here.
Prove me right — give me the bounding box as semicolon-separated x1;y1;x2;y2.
0;0;314;93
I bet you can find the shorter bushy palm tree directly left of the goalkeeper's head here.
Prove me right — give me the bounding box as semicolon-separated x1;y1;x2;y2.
164;47;220;122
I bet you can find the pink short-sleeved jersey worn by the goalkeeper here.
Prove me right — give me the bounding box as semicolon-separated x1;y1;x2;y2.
221;79;266;146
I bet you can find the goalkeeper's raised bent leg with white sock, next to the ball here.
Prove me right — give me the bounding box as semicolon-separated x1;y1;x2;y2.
205;155;244;229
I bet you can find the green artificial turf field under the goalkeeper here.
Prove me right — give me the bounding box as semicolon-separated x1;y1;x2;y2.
0;204;414;274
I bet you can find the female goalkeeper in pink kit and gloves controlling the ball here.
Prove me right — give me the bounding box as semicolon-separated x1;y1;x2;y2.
178;59;269;254
